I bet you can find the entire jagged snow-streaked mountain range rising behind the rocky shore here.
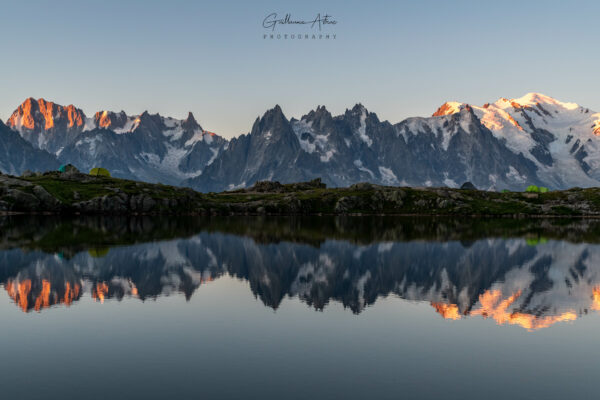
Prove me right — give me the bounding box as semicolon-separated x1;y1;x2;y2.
3;93;600;191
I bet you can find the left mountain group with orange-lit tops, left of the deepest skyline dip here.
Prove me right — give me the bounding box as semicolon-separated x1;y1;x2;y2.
9;98;226;184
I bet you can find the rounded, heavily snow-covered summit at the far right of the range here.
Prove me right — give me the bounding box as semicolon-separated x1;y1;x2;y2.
434;93;600;188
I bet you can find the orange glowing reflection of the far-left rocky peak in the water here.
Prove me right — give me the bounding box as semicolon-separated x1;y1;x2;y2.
5;279;81;312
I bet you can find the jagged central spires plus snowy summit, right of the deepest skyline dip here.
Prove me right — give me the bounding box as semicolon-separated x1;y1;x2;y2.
186;93;600;191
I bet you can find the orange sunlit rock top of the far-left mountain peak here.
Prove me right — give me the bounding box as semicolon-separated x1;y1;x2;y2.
7;98;85;132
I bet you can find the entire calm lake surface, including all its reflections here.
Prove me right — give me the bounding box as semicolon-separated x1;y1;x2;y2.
0;217;600;399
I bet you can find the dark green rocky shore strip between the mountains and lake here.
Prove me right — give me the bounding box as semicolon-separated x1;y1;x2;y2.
0;171;600;217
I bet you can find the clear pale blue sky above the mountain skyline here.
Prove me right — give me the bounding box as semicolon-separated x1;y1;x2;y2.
0;0;600;137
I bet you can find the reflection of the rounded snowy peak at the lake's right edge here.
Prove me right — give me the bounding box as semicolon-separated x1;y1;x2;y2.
399;240;600;329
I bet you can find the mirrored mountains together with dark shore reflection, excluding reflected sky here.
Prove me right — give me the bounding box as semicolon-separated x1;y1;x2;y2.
0;216;600;330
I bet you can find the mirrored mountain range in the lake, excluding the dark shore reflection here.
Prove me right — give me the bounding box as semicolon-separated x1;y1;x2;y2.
0;228;600;330
